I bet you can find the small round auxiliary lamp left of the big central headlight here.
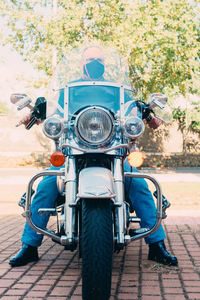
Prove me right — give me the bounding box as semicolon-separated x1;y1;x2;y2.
43;117;64;139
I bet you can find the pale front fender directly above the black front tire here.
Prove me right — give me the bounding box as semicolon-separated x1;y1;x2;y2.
77;167;116;199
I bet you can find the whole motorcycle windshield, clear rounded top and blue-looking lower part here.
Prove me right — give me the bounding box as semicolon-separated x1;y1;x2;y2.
47;46;132;117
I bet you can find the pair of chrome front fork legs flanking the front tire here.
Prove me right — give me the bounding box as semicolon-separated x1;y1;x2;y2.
64;157;127;250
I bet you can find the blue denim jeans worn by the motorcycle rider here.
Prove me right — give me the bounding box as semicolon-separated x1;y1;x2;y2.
21;161;166;247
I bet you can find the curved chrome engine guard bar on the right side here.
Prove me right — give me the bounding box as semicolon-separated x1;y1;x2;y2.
124;172;162;242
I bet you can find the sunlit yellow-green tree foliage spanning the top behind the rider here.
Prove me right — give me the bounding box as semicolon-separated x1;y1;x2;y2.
1;0;200;95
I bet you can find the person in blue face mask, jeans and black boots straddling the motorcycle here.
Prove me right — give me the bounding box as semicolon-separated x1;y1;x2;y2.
9;46;178;267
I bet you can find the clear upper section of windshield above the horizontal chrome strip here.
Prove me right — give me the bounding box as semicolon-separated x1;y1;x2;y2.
54;46;130;88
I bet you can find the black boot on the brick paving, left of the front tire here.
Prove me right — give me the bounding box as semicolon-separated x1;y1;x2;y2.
9;244;39;267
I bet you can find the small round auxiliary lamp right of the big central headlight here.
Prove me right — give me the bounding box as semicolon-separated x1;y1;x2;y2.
124;117;144;138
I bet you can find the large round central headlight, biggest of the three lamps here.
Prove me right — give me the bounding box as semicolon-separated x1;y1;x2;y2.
75;107;113;146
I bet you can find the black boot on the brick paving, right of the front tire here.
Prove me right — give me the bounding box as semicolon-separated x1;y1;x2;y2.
148;241;178;266
